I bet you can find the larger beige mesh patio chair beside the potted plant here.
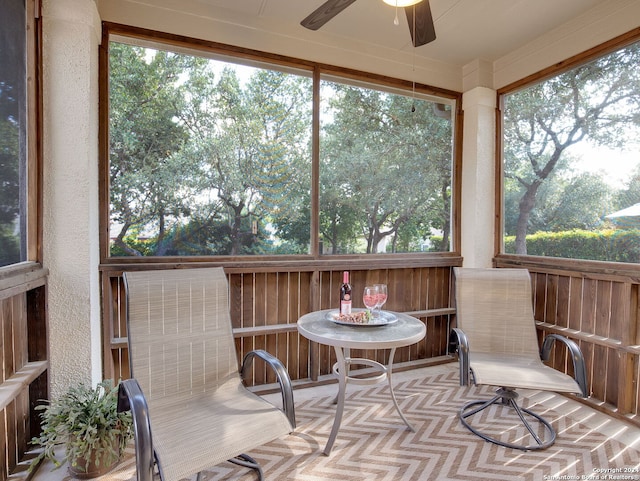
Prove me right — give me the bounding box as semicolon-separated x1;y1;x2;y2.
119;268;295;481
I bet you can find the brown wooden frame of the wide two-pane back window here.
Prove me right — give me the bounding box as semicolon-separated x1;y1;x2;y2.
99;22;462;266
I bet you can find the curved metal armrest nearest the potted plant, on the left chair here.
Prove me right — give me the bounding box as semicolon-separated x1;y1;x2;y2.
117;379;154;481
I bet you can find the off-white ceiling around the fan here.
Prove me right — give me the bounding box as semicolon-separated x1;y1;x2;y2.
190;0;606;67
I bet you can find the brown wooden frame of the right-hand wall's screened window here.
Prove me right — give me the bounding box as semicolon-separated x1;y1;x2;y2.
494;28;640;272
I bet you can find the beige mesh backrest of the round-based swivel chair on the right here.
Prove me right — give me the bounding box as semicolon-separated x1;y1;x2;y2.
454;267;540;358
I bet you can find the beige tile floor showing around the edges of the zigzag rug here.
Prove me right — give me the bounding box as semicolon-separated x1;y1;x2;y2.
23;363;640;481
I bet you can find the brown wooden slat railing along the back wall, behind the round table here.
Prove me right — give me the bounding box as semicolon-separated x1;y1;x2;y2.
103;256;461;385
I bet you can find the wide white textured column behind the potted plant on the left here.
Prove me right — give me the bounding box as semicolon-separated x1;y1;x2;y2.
42;0;102;397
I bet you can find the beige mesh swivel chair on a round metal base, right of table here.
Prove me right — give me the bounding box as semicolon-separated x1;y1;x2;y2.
452;267;587;450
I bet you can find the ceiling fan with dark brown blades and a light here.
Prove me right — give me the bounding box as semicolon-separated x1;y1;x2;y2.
300;0;436;47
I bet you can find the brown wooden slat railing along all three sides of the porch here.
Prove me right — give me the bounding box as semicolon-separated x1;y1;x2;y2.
0;256;640;474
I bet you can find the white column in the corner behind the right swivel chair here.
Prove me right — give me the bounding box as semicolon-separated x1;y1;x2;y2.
461;87;496;267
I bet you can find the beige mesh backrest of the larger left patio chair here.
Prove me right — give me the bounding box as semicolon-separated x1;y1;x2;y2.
124;268;240;404
